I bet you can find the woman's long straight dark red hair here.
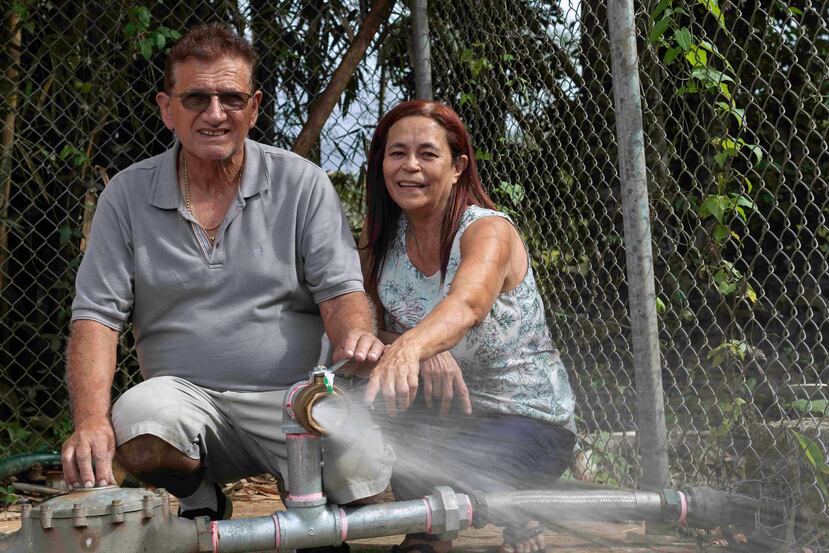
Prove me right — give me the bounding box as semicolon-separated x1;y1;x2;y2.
364;100;495;296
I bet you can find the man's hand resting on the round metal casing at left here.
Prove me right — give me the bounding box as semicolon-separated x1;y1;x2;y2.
61;417;115;488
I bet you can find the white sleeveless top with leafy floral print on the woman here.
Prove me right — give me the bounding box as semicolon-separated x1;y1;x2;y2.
377;206;575;424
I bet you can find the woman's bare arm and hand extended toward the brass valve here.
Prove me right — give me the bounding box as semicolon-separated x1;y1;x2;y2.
365;217;527;416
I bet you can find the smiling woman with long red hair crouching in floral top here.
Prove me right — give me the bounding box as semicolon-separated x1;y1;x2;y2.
361;101;575;553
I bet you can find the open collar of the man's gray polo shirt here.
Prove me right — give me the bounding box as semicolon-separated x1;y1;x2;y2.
150;139;271;209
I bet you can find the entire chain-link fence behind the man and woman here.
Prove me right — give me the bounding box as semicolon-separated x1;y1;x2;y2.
0;0;829;550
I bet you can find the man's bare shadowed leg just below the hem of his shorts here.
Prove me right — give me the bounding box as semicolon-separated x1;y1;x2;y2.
115;434;201;478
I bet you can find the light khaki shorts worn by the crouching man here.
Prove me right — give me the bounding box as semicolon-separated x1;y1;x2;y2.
112;376;395;505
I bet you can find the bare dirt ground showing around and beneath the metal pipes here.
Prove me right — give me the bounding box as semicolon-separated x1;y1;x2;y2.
0;477;698;553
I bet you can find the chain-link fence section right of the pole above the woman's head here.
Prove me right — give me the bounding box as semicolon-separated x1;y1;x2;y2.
430;0;829;548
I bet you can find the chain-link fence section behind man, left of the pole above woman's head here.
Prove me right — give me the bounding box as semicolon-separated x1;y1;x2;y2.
0;0;408;448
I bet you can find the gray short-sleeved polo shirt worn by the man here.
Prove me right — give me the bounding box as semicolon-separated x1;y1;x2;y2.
72;140;363;391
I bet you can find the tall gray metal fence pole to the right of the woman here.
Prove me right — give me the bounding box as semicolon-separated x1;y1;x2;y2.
607;0;668;489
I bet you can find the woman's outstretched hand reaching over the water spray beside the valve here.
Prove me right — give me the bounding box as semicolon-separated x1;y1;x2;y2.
365;340;421;417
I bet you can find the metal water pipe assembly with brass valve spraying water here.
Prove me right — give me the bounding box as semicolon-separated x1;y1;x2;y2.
0;368;757;553
